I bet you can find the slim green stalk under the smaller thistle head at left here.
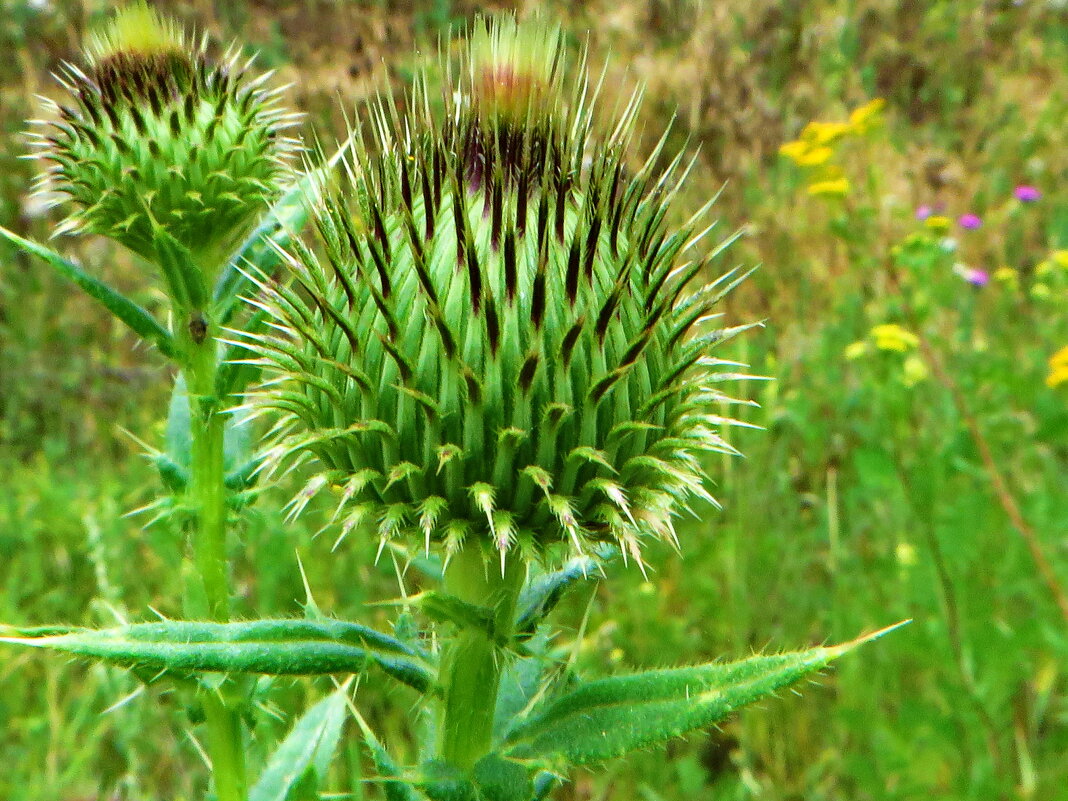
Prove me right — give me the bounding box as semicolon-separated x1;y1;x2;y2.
185;312;248;801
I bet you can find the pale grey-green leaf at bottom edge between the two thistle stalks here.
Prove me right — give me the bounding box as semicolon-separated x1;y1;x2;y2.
249;688;348;801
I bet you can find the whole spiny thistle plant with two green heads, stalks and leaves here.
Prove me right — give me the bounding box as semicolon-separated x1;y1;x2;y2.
0;12;901;801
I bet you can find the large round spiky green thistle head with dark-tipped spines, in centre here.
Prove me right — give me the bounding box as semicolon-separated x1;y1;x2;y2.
250;14;756;557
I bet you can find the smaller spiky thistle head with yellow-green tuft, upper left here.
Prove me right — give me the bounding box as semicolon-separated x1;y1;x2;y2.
30;3;295;276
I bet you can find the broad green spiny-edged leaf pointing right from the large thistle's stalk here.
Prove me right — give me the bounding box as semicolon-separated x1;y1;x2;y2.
504;624;904;765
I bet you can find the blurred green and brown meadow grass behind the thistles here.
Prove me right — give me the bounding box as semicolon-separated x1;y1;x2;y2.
0;0;1068;801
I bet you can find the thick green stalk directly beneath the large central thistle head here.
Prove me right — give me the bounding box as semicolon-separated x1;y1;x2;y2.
439;544;525;771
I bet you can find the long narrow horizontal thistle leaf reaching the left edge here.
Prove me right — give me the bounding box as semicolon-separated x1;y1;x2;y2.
0;619;434;692
